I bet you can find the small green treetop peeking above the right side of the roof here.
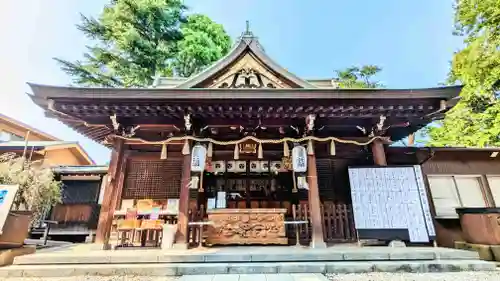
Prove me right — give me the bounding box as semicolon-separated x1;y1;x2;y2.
334;65;383;89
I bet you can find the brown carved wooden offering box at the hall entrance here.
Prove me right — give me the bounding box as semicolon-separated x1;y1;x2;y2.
207;209;288;245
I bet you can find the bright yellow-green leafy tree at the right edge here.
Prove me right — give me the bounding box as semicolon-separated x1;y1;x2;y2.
428;0;500;147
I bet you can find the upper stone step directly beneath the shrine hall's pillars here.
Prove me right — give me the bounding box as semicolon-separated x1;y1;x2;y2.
14;247;479;265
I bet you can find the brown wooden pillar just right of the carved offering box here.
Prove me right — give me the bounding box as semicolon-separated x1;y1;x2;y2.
307;141;326;248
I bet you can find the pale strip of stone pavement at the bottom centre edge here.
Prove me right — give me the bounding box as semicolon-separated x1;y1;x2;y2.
177;273;328;281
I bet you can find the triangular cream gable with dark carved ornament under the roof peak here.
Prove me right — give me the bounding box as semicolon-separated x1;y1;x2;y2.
208;53;291;89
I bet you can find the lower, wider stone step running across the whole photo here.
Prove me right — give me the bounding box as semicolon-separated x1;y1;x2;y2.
0;260;496;277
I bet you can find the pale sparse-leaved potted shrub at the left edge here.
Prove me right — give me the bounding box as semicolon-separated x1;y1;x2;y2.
0;154;61;221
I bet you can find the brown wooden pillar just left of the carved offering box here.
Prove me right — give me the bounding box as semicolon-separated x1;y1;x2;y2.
175;144;191;248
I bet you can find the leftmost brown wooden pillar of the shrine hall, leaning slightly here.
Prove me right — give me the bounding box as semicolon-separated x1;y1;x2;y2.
96;139;125;245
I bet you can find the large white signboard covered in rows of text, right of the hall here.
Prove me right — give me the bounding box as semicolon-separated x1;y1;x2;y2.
349;166;435;242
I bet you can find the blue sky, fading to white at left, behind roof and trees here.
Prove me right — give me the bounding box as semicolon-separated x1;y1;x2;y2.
0;0;462;163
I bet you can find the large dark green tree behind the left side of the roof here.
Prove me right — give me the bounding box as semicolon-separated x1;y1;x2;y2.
55;0;231;87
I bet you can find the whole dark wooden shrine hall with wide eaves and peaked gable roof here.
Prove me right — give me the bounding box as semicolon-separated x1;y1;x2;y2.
30;27;461;247
